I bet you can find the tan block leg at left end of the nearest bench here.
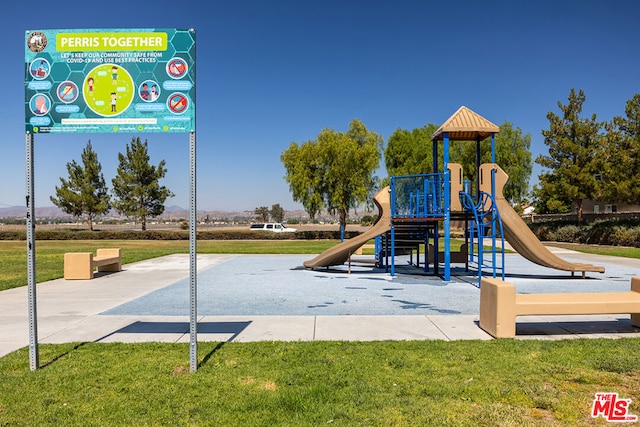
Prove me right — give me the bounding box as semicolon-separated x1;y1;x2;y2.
480;278;516;338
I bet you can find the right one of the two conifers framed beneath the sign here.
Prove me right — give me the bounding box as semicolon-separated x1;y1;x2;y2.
111;137;173;230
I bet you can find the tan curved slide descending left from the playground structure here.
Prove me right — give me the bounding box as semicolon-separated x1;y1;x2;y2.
303;187;391;268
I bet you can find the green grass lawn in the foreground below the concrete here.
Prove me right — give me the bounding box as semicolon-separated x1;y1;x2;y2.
0;339;640;427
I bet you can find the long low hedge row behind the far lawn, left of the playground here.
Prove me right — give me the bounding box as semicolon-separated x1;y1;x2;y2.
0;229;360;240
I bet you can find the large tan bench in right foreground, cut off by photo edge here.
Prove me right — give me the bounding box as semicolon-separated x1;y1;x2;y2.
480;276;640;338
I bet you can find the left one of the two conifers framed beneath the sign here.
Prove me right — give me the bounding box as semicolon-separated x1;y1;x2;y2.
50;141;111;230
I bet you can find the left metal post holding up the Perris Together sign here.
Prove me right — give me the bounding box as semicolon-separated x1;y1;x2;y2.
26;132;40;371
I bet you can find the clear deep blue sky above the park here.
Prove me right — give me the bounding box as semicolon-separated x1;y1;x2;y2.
0;0;640;210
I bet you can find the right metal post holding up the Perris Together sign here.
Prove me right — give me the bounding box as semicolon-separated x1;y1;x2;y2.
189;132;198;372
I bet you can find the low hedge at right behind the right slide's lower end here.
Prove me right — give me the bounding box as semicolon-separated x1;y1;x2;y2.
529;219;640;248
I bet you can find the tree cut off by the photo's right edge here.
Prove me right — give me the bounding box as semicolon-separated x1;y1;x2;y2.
598;94;640;204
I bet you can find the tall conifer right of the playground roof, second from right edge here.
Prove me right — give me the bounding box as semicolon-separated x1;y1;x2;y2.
536;88;602;224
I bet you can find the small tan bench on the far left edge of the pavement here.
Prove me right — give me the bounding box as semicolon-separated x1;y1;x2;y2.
64;248;122;280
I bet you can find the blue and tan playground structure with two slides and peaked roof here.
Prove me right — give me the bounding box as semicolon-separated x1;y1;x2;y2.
304;106;604;286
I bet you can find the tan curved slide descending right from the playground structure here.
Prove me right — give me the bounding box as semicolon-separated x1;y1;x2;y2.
480;163;604;276
